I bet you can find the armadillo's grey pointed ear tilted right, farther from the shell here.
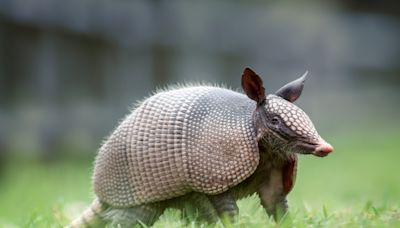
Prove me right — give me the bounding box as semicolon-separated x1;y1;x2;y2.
275;71;308;102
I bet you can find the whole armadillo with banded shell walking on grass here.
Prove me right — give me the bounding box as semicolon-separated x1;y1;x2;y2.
71;68;333;227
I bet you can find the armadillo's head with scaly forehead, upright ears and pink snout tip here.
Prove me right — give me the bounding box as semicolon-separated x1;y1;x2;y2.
242;68;333;157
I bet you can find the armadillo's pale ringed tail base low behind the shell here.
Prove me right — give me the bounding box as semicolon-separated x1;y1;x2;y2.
67;198;107;228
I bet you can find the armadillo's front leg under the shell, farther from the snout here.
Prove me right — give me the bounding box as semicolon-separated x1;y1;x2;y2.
208;191;239;227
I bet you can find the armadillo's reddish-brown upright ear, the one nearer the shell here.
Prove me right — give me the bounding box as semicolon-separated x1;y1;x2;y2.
242;67;265;105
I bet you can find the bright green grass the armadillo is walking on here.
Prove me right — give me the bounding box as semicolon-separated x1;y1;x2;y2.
0;127;400;227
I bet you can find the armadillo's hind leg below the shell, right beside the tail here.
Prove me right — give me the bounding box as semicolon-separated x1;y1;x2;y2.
105;203;165;227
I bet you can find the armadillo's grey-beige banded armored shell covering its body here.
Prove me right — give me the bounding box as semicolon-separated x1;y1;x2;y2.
93;87;259;207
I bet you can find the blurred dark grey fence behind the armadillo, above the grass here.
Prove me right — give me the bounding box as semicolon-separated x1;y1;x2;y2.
0;0;400;158
